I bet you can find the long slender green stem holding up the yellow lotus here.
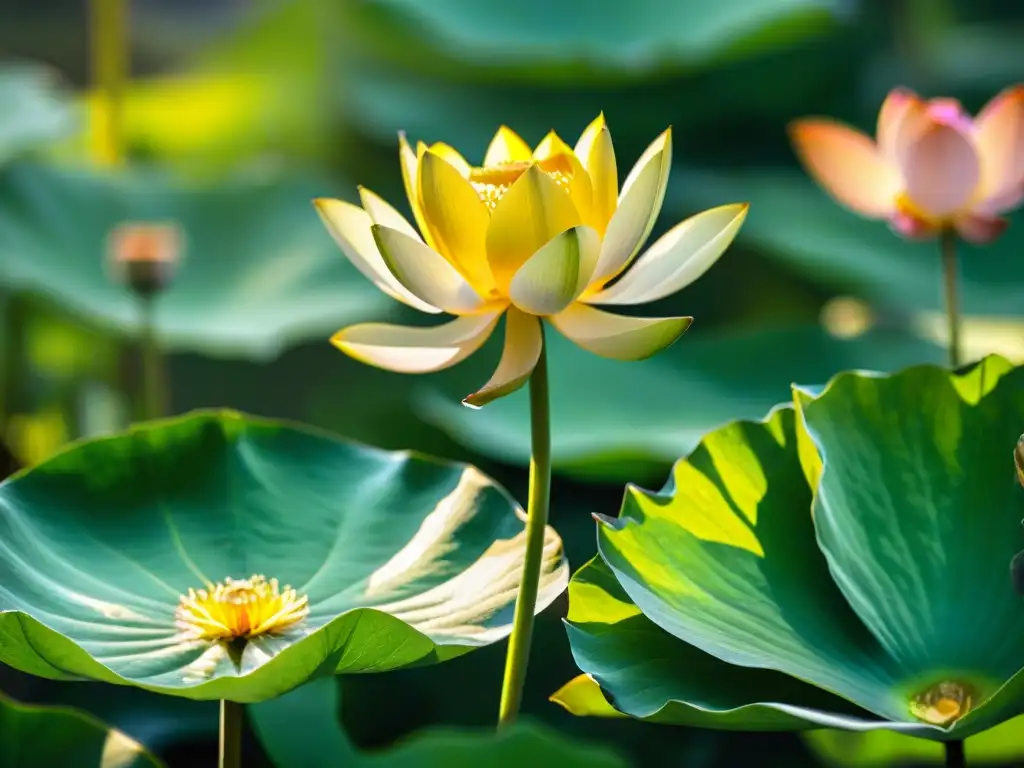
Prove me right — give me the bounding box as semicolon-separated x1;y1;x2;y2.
498;329;551;728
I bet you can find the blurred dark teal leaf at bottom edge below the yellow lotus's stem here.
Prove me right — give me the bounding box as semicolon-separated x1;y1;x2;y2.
248;680;626;768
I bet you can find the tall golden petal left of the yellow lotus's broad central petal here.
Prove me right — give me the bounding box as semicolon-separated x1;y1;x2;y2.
419;151;495;296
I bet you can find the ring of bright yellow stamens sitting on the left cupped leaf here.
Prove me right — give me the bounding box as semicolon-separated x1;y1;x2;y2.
175;575;309;643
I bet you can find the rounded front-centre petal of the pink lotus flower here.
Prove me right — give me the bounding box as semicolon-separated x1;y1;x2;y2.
900;121;981;218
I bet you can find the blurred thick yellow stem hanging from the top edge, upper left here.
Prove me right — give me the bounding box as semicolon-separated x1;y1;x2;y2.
89;0;129;166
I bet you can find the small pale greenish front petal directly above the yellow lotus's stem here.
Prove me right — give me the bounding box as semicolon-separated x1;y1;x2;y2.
509;226;601;315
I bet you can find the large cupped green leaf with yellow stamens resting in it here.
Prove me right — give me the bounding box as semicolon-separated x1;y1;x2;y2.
0;413;567;701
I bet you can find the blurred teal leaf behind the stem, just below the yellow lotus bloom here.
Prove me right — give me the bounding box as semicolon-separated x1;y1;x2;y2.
414;326;945;481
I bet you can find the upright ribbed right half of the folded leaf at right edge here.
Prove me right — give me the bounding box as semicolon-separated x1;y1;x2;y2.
796;357;1024;730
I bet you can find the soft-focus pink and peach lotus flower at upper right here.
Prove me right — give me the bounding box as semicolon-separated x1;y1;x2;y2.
790;85;1024;243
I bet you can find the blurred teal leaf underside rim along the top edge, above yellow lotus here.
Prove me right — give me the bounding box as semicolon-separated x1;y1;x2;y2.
339;0;843;79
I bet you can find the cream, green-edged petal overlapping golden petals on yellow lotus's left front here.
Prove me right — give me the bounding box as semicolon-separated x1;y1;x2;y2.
373;224;486;314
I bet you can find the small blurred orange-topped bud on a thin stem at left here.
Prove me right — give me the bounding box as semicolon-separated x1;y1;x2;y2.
108;222;183;297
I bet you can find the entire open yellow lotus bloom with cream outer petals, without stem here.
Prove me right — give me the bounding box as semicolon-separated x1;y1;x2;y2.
315;116;746;407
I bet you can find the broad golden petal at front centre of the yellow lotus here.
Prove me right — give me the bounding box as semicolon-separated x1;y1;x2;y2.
481;165;582;293
